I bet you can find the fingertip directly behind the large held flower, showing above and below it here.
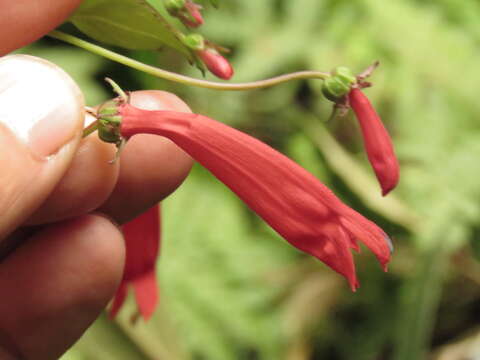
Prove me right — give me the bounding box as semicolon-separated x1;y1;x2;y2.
101;90;193;223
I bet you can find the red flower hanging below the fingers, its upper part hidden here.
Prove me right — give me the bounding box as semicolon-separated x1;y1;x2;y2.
110;205;160;320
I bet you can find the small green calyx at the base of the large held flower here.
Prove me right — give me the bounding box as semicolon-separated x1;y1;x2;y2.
97;98;123;145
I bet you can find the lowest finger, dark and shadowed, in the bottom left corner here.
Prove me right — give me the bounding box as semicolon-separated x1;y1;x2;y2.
0;215;124;360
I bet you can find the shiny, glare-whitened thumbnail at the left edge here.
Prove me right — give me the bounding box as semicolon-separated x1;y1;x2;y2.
0;55;84;157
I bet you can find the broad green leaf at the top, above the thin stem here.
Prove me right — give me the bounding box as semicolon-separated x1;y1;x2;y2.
69;0;194;60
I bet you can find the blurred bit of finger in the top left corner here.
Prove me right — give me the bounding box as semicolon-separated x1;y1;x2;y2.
0;0;81;56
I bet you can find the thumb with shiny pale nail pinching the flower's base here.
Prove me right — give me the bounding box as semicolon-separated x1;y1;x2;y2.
0;55;84;242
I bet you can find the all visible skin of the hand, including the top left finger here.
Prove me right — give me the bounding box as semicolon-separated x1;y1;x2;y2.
0;0;192;360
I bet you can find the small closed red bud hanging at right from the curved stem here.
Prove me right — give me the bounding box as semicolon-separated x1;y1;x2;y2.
348;88;400;196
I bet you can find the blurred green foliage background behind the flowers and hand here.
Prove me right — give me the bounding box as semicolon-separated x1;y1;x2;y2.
16;0;480;360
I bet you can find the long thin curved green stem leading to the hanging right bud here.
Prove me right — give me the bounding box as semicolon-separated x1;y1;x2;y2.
48;30;330;91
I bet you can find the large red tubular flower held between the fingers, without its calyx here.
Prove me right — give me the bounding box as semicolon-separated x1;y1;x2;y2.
118;104;391;290
